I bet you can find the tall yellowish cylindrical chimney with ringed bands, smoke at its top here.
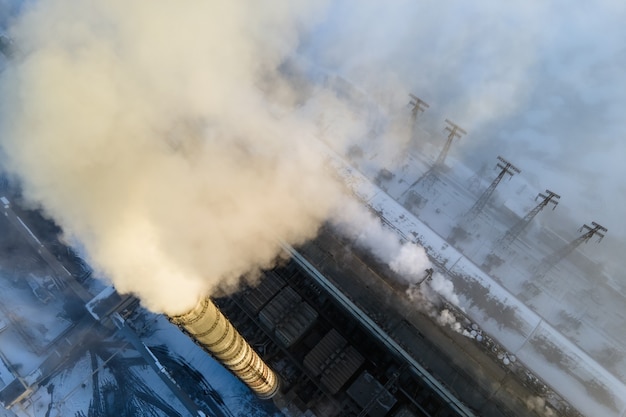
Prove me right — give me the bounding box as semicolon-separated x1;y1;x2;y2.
170;297;278;399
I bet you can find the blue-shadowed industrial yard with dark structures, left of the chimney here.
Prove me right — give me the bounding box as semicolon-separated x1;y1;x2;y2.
0;190;277;417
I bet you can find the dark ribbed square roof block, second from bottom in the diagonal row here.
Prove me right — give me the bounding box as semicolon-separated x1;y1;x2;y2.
304;329;365;394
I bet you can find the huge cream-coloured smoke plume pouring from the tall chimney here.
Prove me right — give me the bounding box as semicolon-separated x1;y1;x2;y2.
0;0;346;313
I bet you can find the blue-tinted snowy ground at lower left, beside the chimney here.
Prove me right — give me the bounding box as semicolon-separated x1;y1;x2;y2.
0;199;281;417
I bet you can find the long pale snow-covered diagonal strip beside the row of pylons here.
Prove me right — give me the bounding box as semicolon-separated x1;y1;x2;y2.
326;137;626;416
